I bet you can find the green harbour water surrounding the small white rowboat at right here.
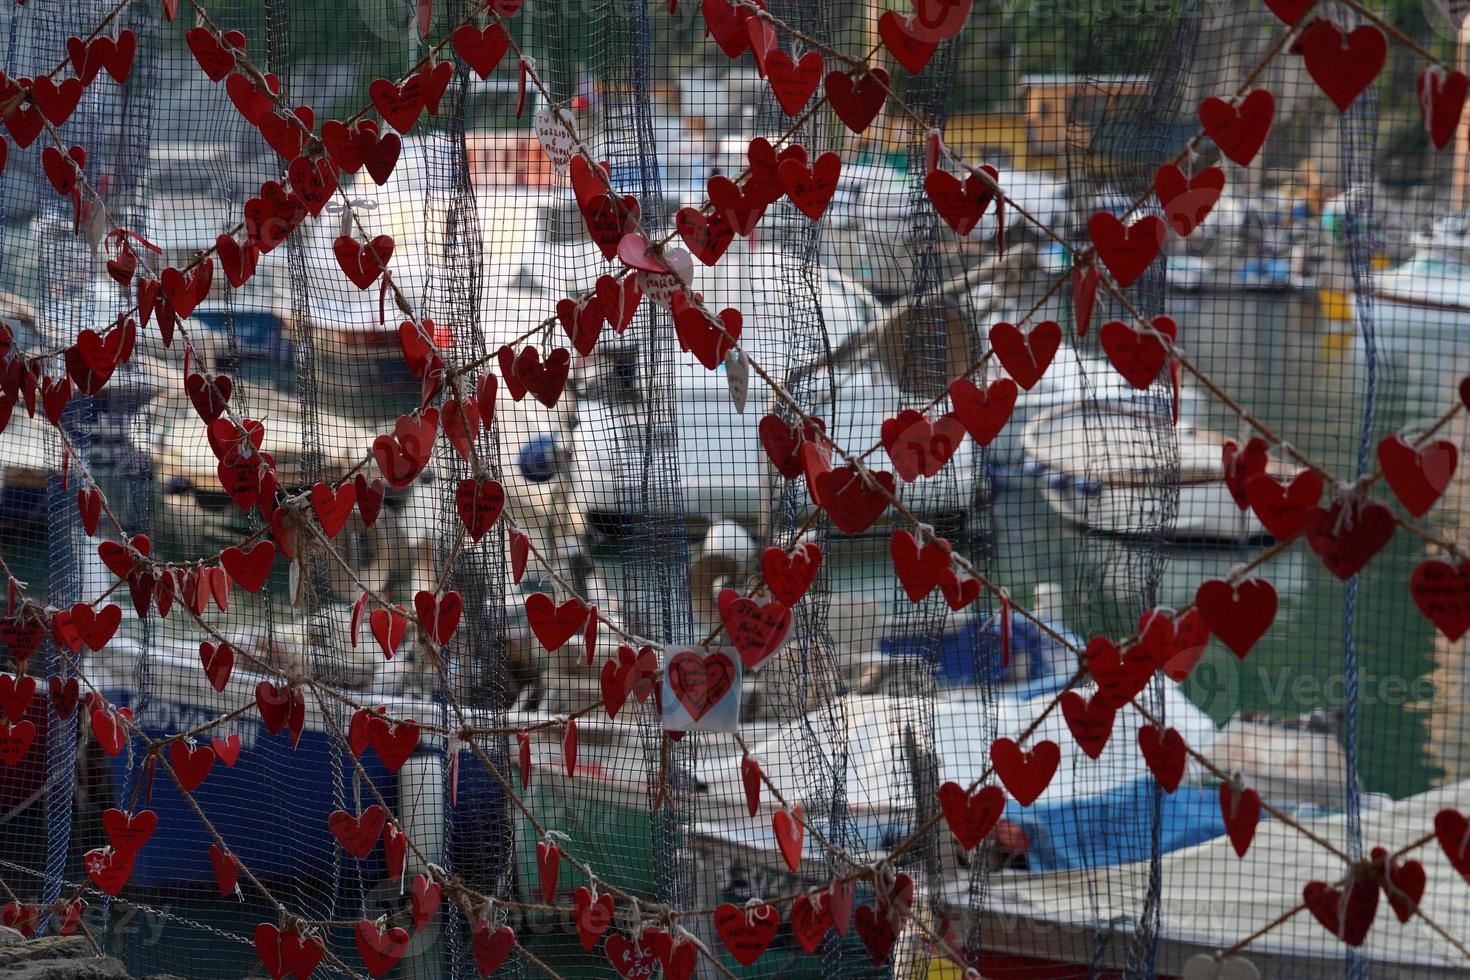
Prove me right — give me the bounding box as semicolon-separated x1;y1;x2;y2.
997;294;1446;798
